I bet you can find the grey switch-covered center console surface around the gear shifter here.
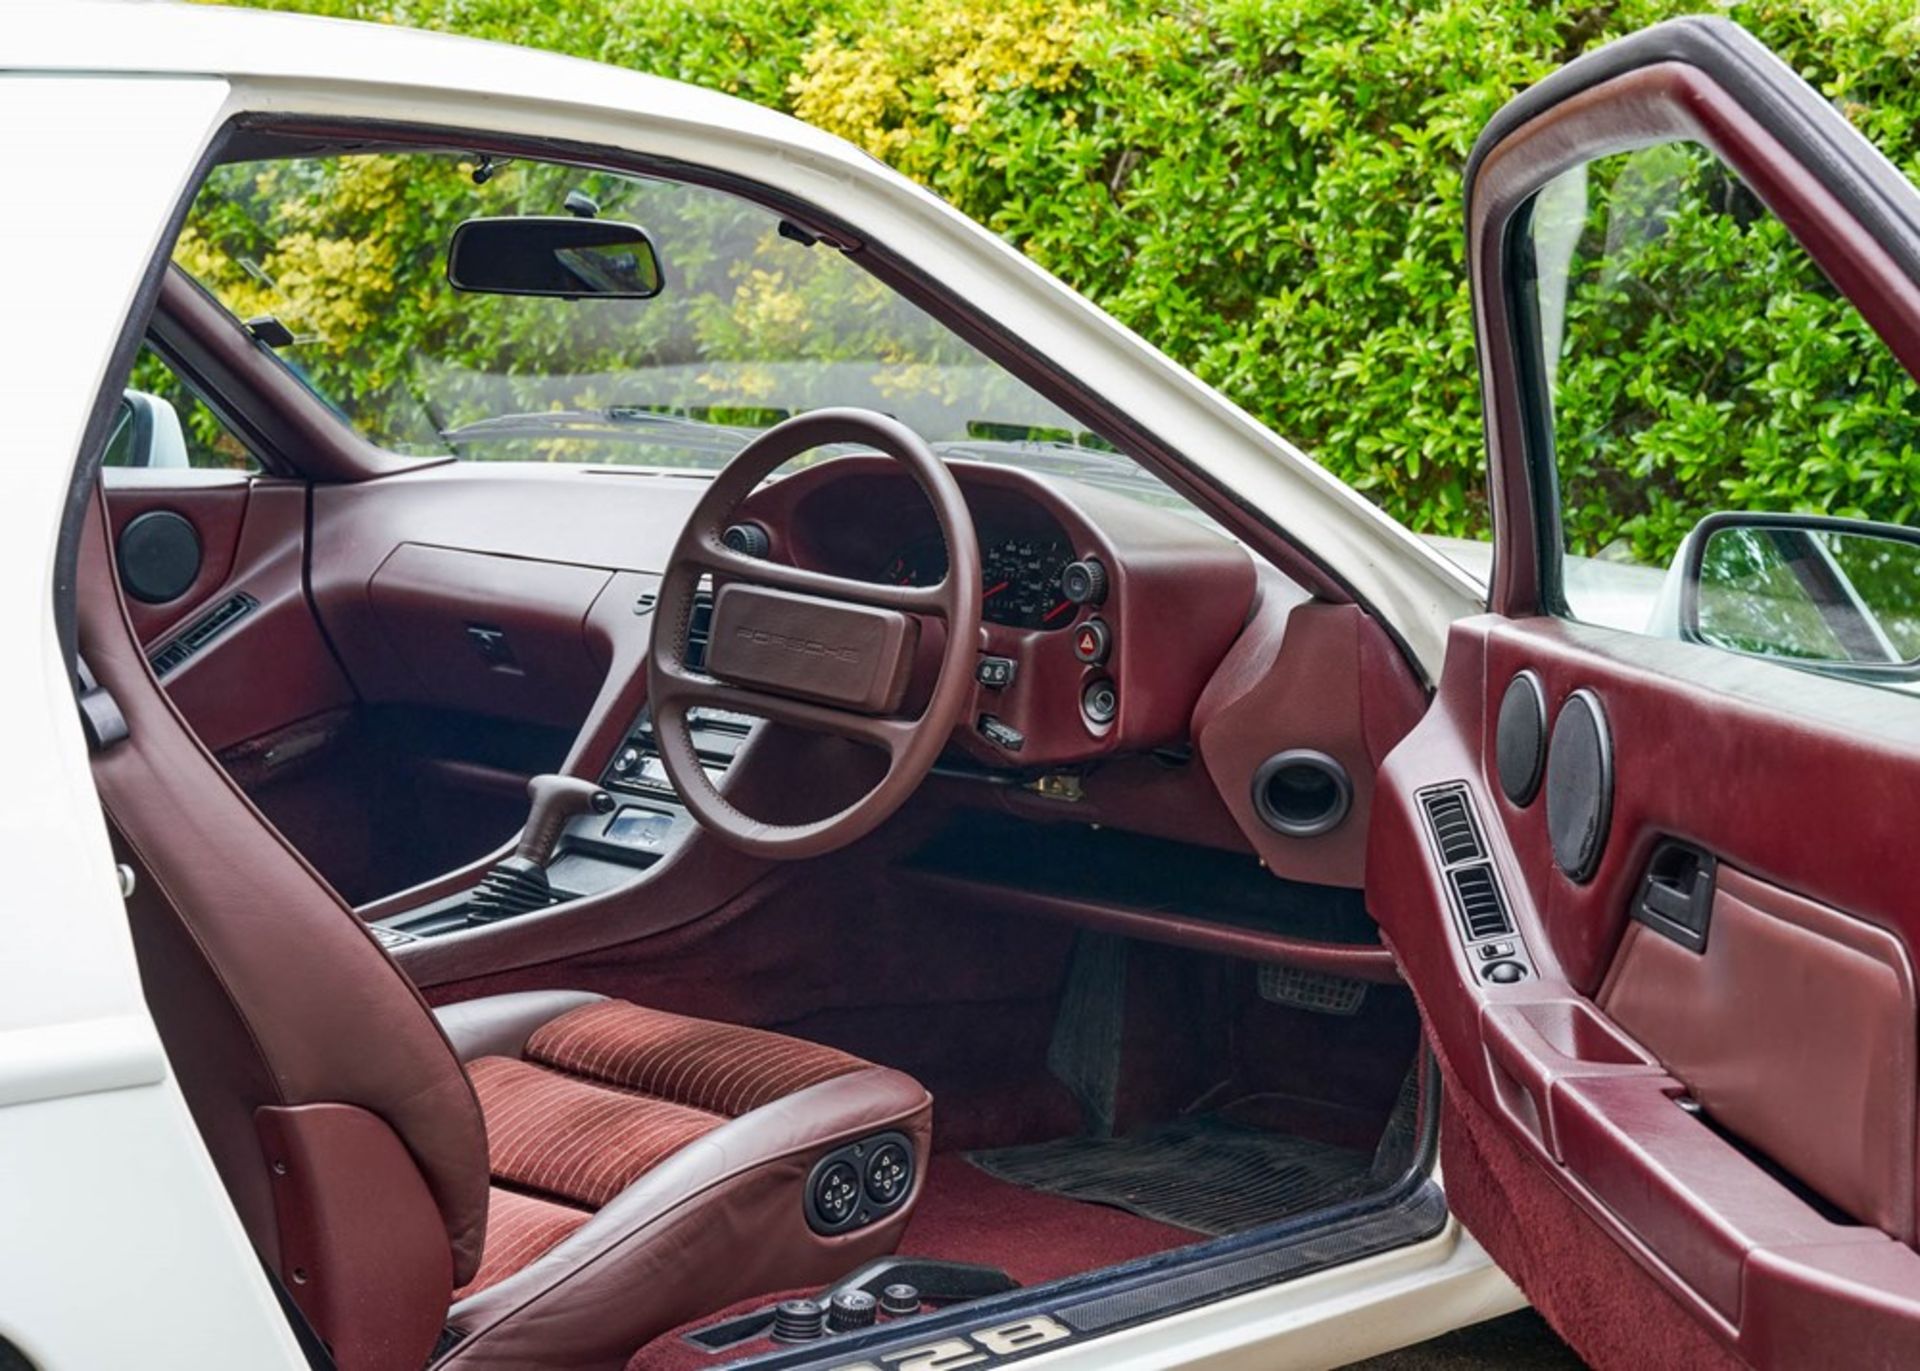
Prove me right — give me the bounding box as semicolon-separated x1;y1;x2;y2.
371;709;755;947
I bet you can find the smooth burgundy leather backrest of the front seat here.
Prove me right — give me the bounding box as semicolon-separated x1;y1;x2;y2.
75;499;488;1333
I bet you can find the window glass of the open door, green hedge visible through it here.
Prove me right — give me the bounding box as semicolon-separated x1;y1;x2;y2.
1519;142;1920;661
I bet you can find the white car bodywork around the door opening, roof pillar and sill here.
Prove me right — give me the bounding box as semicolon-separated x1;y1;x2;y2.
0;4;1521;1371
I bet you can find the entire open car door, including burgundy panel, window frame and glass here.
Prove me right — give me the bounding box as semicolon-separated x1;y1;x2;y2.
1367;19;1920;1367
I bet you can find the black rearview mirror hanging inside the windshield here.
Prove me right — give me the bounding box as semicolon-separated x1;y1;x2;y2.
447;215;660;300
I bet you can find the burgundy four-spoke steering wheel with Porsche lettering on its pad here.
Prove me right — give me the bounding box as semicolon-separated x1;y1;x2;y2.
647;409;981;858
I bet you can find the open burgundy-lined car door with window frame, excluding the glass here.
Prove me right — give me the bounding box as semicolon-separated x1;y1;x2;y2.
1367;19;1920;1344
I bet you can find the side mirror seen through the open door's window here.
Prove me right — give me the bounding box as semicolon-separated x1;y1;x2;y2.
1678;515;1920;680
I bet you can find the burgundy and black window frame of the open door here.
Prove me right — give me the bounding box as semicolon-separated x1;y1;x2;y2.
1465;38;1920;618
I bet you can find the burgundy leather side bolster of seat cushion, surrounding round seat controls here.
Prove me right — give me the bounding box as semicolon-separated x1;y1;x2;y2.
440;1066;933;1369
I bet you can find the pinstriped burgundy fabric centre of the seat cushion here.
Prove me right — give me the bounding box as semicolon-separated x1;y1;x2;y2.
455;1000;872;1298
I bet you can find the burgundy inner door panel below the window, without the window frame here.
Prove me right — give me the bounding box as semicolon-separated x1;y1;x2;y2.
1369;616;1920;1363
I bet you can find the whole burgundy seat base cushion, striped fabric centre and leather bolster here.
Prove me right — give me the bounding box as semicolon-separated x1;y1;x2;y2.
436;997;931;1369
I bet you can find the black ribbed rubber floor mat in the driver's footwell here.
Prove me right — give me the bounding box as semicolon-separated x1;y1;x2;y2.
968;1114;1377;1237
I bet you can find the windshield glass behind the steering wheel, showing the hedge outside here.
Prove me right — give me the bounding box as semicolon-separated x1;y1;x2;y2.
175;152;1185;503
